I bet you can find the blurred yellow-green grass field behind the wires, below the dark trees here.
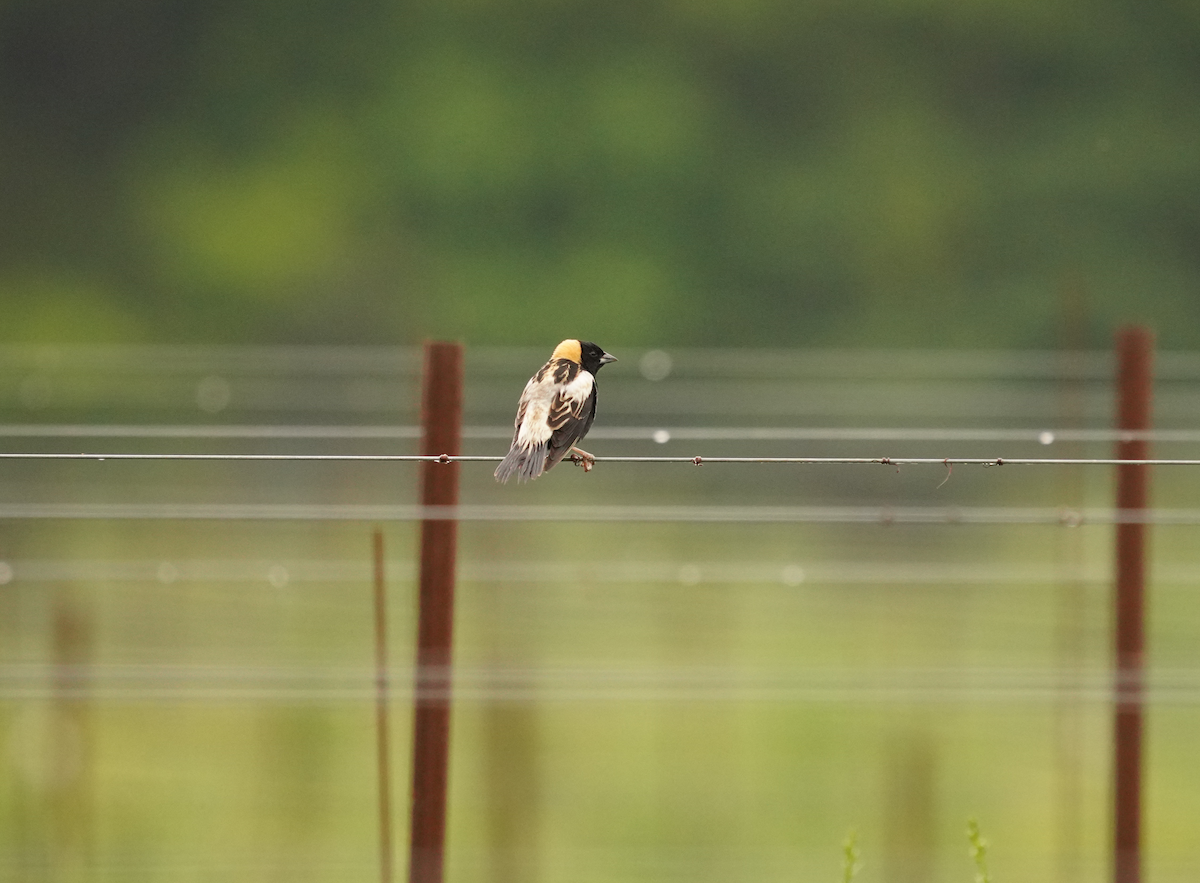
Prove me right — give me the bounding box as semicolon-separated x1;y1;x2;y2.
0;346;1200;883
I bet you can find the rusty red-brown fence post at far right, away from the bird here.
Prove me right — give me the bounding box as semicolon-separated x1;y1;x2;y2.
1112;328;1154;883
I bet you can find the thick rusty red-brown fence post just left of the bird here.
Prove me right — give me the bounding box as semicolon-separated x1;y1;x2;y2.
408;342;462;883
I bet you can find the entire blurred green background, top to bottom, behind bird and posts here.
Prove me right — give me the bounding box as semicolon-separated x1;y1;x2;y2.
0;0;1200;883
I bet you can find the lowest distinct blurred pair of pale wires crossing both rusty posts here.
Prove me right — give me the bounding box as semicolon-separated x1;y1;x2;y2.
0;662;1200;705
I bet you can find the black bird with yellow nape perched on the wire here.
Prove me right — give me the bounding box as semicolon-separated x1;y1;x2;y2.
496;341;617;481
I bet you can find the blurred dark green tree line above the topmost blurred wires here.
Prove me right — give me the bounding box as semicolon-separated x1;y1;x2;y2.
0;0;1200;347
